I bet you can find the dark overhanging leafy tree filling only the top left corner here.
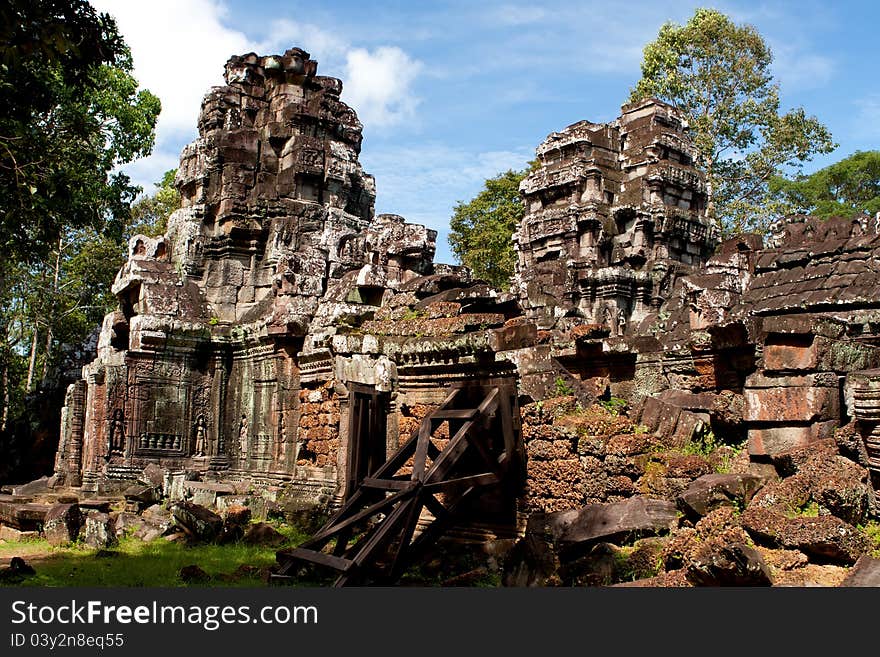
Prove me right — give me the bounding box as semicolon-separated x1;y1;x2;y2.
0;0;160;261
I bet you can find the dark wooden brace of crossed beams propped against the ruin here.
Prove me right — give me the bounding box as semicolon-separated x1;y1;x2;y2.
272;380;525;586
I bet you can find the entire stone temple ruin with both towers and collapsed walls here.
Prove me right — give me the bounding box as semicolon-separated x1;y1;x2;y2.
0;49;880;583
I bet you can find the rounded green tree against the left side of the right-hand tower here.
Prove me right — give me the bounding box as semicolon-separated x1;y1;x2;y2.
449;169;529;289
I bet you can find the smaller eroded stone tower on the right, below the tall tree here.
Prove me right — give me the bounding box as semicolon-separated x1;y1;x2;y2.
514;99;718;335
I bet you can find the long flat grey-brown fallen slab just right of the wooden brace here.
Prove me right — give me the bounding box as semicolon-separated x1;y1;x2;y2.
540;497;678;550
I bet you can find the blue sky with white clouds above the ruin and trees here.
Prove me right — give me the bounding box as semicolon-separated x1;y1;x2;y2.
92;0;880;262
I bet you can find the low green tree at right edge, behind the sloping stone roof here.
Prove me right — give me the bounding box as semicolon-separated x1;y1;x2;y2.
769;151;880;218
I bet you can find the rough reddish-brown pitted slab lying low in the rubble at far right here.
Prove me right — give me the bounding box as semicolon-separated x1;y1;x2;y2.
742;507;871;564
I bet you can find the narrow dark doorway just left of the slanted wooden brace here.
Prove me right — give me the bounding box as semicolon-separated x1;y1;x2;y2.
345;383;388;499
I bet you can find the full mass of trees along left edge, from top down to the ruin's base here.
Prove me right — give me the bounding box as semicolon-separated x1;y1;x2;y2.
0;0;160;436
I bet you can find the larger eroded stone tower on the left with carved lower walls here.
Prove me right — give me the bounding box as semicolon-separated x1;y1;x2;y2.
58;48;380;488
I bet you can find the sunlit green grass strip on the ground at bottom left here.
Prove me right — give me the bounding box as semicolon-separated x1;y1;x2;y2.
0;525;316;587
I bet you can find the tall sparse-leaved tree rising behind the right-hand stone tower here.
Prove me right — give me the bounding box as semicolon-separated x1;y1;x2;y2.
630;9;836;234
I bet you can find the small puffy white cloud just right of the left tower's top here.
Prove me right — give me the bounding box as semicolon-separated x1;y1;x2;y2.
342;46;422;128
